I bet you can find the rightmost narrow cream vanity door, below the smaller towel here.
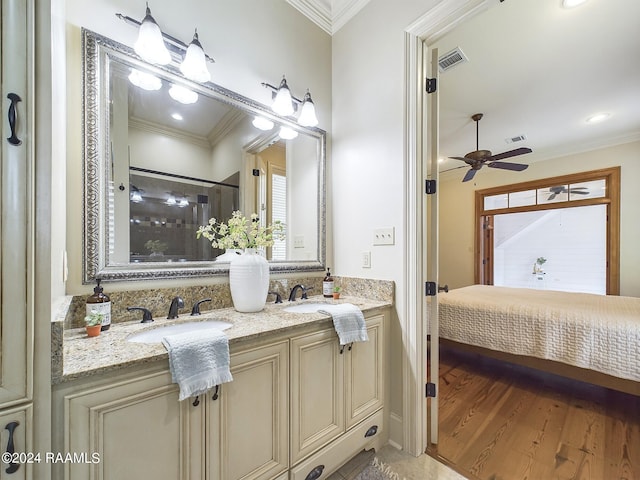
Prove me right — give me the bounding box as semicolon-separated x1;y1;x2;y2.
344;315;385;429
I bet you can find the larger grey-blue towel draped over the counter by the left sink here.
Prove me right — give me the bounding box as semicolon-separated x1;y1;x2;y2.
162;329;233;400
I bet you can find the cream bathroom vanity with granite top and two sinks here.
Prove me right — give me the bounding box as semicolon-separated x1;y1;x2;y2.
54;297;391;480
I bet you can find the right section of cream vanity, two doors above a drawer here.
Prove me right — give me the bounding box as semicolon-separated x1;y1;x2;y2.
291;313;386;480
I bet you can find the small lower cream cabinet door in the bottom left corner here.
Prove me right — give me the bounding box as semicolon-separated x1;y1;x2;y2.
0;405;31;480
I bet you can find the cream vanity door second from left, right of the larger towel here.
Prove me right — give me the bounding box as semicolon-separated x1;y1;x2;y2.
206;341;289;480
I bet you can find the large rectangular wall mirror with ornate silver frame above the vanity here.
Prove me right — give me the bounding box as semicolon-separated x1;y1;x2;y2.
82;29;326;283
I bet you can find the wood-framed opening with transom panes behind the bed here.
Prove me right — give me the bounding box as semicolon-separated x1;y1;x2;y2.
474;167;620;295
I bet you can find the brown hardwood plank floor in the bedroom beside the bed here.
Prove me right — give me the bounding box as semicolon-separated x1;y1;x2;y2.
427;349;640;480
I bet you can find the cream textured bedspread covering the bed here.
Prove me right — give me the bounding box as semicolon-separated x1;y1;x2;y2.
438;285;640;381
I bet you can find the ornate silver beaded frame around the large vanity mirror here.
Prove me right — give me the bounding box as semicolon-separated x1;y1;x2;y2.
82;29;326;284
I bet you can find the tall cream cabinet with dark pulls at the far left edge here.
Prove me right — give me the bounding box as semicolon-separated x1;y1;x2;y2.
0;0;34;480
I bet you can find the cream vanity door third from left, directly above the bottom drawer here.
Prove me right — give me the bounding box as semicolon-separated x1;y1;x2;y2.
291;329;346;464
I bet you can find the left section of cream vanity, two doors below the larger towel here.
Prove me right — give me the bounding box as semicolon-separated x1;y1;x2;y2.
57;340;289;480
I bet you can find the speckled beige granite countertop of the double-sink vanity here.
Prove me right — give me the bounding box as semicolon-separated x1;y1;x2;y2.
52;295;391;383
